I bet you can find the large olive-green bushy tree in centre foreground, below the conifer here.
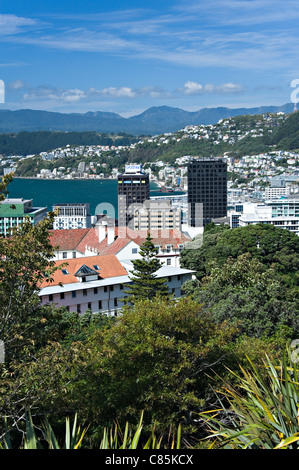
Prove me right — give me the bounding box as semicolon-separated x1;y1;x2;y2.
83;298;240;429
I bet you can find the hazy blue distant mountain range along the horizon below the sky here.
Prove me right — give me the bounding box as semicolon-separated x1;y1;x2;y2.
0;103;294;136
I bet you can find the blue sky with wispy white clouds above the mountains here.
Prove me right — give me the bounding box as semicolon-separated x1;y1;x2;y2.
0;0;299;117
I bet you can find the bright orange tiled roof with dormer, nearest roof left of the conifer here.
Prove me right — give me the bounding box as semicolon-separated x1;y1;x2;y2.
40;255;127;287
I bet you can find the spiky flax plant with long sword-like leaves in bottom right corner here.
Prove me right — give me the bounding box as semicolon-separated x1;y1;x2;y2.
201;346;299;449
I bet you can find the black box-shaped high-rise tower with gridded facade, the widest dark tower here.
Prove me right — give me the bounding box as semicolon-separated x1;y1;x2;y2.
188;158;227;227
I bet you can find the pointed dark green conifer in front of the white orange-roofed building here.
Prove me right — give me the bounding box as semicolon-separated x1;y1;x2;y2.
125;233;169;304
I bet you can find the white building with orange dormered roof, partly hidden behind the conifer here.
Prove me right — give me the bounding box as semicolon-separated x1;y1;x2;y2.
39;255;194;316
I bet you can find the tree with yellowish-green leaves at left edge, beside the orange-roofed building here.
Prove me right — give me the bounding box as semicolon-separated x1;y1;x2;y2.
0;213;63;364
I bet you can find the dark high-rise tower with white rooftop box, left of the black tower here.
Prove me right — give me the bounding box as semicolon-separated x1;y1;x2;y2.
118;164;150;227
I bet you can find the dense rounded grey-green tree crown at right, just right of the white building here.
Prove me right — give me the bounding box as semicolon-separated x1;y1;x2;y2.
185;253;299;343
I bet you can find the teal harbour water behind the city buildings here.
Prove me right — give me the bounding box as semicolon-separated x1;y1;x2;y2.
8;178;183;217
